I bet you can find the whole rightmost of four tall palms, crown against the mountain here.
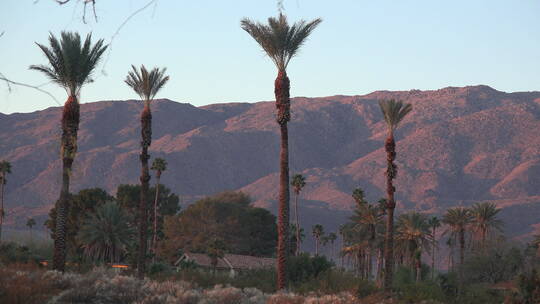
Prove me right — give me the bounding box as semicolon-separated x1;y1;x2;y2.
379;99;412;291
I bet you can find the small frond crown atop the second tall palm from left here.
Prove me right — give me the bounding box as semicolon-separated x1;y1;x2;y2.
124;65;169;102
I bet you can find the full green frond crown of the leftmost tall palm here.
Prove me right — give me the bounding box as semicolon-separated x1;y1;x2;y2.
30;32;107;96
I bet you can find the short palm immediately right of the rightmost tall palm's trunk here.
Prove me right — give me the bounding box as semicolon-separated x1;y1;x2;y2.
396;211;433;282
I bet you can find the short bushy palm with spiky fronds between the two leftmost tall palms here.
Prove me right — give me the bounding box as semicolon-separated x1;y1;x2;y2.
77;201;135;263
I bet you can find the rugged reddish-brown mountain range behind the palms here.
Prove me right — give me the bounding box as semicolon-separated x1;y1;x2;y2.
0;86;540;242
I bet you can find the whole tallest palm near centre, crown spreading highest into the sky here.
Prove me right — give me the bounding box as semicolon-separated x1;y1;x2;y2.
241;13;321;290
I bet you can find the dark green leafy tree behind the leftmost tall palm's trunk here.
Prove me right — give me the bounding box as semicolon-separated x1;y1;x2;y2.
44;188;114;259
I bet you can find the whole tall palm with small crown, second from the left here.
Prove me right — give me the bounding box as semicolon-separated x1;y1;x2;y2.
124;65;169;278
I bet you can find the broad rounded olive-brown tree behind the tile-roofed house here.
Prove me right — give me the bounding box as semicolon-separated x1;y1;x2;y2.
161;191;277;260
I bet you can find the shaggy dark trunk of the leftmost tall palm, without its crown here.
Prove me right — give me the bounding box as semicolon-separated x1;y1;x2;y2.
53;96;80;272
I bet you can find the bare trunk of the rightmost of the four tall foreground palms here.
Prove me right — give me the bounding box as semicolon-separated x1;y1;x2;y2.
384;131;396;292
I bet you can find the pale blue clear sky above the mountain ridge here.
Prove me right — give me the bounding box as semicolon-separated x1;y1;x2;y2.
0;0;540;114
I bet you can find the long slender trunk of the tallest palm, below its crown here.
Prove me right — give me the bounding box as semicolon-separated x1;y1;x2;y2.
274;70;291;290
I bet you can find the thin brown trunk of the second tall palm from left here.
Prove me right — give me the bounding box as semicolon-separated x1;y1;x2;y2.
137;101;152;279
